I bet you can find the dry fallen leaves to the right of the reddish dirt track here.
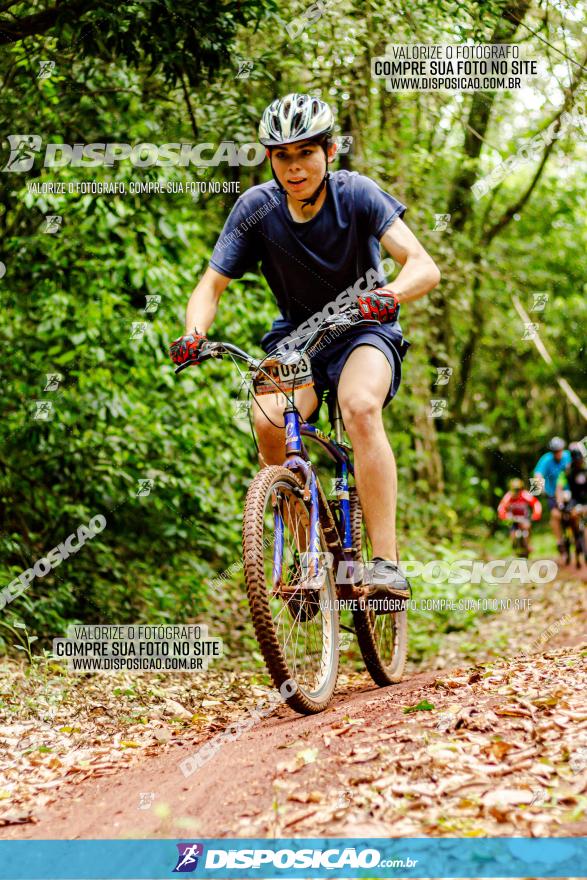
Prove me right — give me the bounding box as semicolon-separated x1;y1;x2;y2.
238;643;587;837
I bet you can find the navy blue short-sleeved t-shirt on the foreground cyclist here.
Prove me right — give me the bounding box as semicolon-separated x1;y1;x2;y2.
210;171;406;325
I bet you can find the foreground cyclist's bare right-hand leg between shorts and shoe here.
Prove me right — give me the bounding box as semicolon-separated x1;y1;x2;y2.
338;345;397;561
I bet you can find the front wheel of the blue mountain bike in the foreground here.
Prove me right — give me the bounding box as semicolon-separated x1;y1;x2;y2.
243;465;339;714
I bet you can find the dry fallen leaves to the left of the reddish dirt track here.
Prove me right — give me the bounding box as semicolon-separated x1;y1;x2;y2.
0;659;268;826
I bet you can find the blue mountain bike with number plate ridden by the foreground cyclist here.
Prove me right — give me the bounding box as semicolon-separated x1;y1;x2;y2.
175;309;407;714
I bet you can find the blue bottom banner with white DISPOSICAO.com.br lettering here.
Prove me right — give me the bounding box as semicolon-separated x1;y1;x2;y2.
0;837;587;880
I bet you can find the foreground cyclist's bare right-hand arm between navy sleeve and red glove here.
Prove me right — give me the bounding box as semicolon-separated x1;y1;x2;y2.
381;217;440;303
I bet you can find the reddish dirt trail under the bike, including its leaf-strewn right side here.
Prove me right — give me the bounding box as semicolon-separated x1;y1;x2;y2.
0;564;587;839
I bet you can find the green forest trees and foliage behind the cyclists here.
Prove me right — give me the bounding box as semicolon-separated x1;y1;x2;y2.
0;0;587;638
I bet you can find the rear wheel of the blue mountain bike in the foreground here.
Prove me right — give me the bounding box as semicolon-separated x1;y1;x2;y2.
350;488;408;687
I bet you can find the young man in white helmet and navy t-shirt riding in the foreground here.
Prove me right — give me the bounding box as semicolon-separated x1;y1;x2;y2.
170;93;440;600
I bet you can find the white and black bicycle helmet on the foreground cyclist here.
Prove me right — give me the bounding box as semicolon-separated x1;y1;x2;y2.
259;92;334;147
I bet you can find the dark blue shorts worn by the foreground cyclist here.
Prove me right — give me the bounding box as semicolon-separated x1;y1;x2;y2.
261;318;410;422
